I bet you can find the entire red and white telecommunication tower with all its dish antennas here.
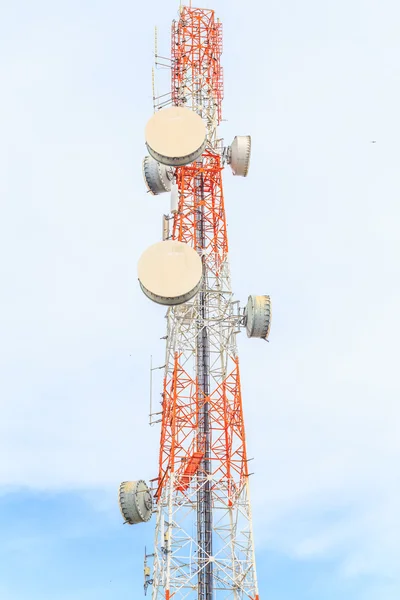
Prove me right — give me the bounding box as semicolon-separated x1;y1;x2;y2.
119;6;271;600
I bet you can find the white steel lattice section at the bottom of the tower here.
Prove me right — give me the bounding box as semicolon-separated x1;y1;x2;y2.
153;479;256;600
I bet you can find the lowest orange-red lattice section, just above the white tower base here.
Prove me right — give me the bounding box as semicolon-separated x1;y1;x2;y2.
157;354;248;505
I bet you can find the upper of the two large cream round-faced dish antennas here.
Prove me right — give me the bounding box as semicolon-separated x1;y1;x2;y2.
145;106;206;167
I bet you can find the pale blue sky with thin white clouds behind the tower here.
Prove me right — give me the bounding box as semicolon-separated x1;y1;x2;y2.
0;0;400;600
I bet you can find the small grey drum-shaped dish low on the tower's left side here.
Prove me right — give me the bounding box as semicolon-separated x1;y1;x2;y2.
118;480;153;525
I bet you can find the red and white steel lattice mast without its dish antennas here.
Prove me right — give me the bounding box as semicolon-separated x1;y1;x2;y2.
146;7;259;600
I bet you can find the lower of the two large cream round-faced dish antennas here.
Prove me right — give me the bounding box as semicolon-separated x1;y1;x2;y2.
138;240;203;306
